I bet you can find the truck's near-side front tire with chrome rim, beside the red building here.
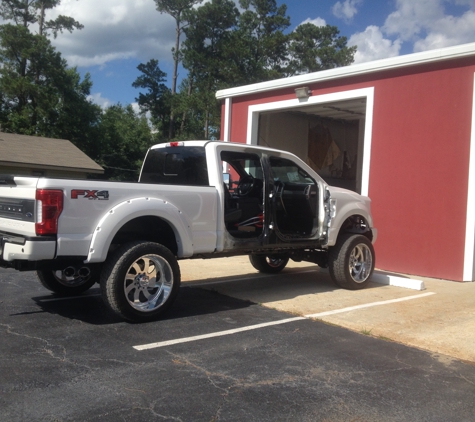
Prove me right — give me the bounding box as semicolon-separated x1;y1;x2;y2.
328;234;375;290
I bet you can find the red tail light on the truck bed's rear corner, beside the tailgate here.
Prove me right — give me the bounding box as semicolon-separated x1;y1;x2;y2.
35;189;63;236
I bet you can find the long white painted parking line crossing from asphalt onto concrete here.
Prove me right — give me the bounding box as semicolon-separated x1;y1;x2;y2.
133;292;435;351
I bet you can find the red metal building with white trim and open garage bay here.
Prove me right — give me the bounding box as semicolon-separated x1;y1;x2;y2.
216;43;475;281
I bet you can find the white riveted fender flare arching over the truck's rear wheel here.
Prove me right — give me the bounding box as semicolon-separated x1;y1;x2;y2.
85;197;193;263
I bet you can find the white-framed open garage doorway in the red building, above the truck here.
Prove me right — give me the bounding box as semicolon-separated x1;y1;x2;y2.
248;88;373;195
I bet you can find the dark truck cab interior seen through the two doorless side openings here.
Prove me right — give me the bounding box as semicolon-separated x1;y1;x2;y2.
221;151;318;238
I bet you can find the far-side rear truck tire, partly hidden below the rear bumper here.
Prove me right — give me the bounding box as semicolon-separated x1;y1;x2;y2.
36;266;100;296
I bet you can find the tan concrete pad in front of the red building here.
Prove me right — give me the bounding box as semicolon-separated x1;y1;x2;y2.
180;257;475;362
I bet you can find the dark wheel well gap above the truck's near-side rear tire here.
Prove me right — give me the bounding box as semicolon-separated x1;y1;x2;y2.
112;216;178;255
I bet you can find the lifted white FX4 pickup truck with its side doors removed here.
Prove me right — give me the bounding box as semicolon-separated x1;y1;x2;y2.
0;141;377;322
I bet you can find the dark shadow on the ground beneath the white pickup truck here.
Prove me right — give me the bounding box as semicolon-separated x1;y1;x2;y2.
25;266;381;325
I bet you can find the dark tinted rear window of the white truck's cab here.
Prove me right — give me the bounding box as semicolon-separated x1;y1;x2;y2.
140;147;209;186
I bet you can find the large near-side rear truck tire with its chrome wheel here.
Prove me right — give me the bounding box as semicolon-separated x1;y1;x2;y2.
101;241;180;322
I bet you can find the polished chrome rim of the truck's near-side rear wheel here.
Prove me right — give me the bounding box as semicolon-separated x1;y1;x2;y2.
124;255;173;312
